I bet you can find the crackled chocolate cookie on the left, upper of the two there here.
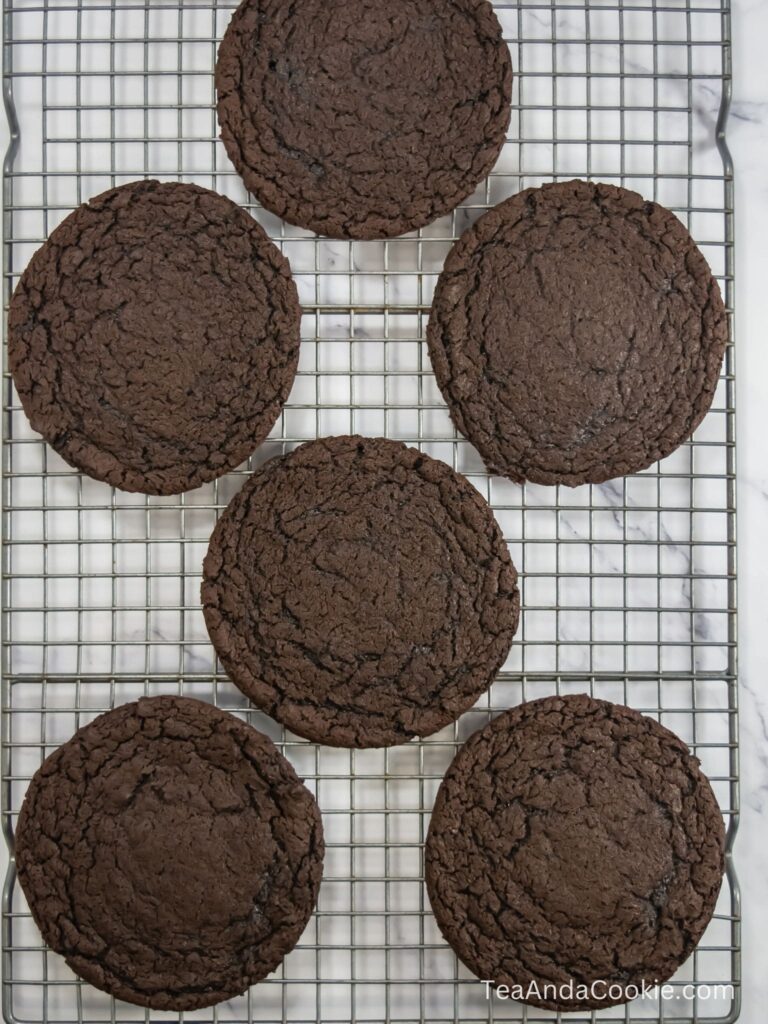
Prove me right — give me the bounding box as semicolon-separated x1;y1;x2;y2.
8;181;300;495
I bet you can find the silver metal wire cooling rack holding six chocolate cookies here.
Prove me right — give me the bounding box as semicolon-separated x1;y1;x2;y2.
2;0;739;1024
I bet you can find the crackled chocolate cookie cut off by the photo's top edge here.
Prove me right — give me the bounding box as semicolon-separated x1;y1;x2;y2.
216;0;512;239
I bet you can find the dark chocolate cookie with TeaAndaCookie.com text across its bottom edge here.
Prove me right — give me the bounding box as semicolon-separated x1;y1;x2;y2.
426;695;725;1012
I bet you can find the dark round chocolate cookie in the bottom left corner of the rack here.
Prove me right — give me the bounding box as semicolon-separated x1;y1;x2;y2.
15;696;324;1011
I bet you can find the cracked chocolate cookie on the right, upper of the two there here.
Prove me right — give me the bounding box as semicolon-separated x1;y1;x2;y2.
428;181;728;486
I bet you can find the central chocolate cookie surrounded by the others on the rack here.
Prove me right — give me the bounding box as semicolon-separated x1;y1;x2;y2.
202;437;519;746
